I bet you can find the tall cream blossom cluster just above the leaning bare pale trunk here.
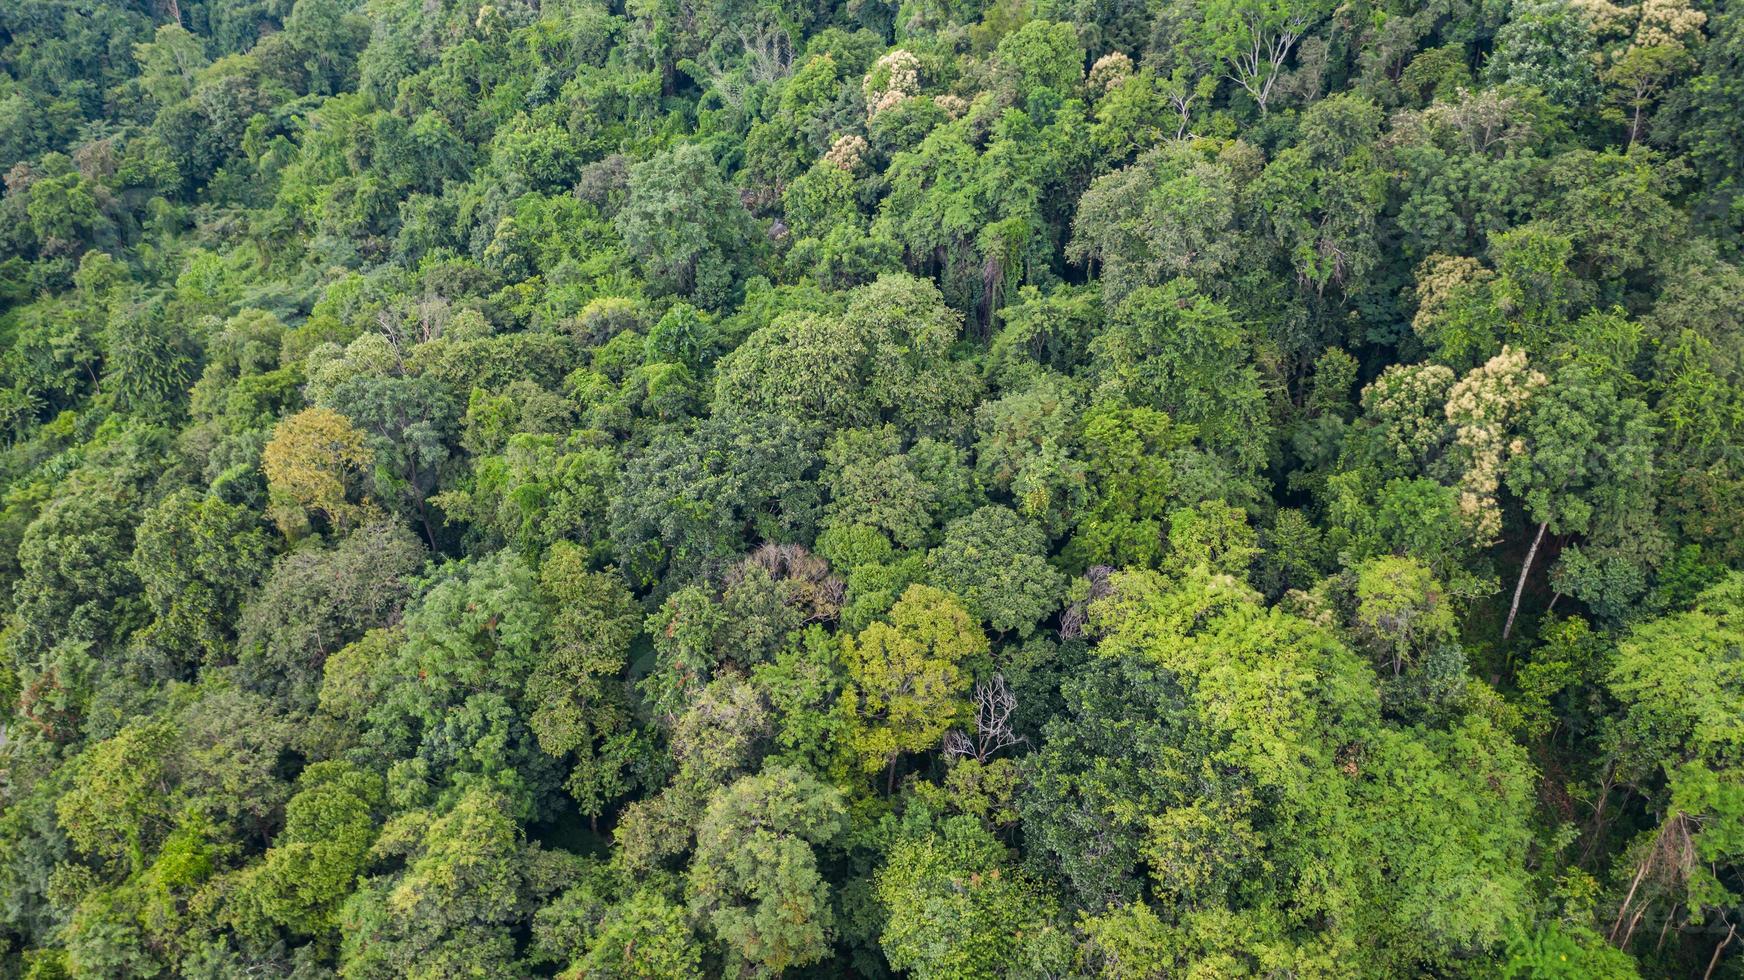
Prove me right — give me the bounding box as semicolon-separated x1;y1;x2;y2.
1448;347;1547;544
